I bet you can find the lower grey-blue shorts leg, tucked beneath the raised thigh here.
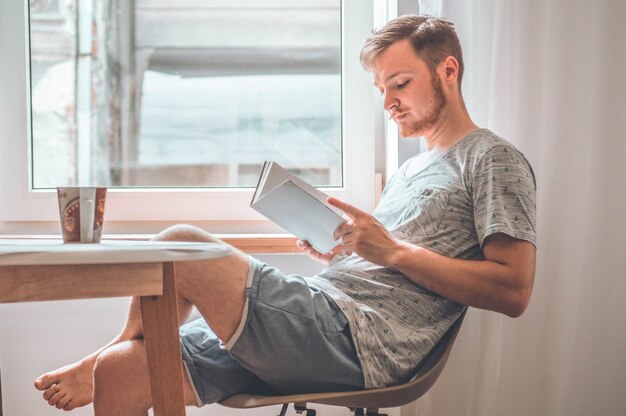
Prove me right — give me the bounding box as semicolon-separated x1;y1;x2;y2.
180;318;275;406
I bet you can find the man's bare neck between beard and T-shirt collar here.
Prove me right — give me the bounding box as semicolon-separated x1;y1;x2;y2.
422;102;478;151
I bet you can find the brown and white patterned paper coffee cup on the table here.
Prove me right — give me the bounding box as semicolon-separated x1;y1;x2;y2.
57;186;107;243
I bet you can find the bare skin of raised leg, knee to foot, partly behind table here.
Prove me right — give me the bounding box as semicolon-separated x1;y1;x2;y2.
35;225;249;410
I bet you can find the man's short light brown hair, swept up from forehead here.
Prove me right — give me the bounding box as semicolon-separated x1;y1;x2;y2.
361;15;464;91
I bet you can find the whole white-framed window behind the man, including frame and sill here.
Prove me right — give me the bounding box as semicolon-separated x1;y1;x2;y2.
0;0;374;229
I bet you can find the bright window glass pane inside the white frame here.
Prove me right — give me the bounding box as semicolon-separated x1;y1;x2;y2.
30;0;342;188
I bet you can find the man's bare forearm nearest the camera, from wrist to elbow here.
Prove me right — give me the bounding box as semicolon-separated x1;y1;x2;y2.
389;243;534;316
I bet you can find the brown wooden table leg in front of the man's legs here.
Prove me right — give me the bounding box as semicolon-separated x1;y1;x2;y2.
141;263;185;416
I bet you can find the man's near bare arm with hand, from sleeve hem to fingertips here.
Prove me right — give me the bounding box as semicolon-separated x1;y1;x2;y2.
329;198;535;317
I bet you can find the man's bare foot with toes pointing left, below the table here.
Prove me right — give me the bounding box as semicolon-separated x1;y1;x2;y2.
35;360;95;410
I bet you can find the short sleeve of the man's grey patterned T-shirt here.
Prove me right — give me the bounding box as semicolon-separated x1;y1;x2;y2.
472;144;537;247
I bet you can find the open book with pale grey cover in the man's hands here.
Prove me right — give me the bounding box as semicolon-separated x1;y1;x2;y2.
250;162;346;253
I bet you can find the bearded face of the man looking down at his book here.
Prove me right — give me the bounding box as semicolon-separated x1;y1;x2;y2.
374;40;447;137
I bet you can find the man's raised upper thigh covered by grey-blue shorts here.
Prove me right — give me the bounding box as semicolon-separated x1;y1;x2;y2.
226;260;363;393
